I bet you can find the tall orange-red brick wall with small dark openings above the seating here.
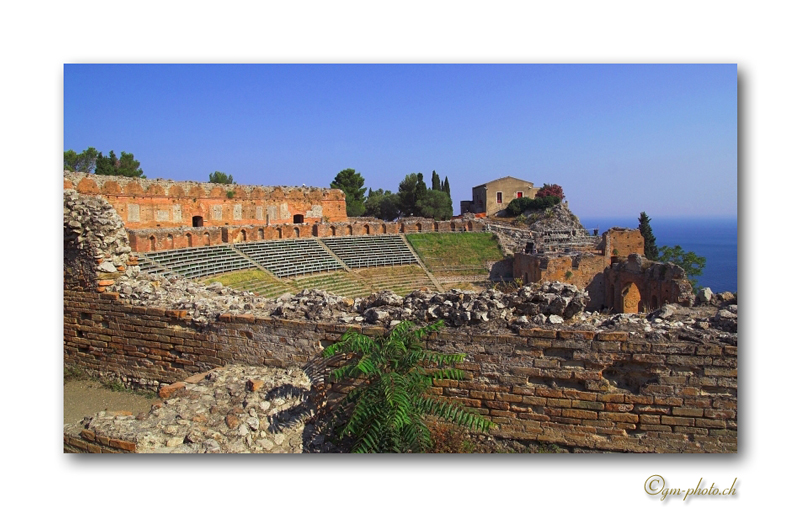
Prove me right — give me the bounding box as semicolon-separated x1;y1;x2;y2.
64;171;347;229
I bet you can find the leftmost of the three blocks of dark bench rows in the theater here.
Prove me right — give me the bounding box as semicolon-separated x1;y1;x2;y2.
141;245;254;278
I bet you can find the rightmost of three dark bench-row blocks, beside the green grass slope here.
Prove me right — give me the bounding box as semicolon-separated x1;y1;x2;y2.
322;235;418;269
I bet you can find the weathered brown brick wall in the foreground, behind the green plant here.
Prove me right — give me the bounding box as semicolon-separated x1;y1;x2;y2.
64;290;737;452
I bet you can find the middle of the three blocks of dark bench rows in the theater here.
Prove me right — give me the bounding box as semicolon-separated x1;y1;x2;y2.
235;238;343;278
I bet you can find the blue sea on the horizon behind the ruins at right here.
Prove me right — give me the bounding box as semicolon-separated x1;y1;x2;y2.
581;214;738;293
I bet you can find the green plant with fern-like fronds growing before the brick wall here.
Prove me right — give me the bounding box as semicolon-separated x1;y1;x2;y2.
323;321;494;453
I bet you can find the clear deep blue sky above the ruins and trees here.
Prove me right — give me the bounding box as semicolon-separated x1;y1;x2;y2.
64;64;737;218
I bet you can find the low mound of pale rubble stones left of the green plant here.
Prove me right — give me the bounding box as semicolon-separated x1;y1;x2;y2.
64;365;324;453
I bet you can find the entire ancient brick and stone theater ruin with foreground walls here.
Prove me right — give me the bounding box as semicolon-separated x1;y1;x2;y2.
64;172;738;453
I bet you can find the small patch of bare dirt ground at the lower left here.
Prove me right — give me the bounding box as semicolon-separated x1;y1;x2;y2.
64;380;158;424
